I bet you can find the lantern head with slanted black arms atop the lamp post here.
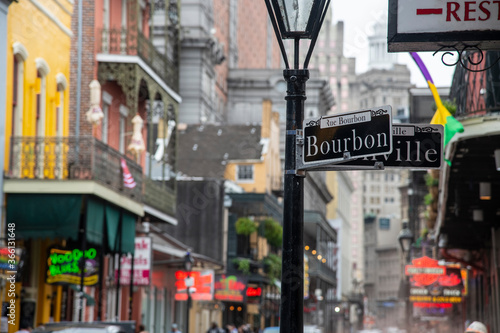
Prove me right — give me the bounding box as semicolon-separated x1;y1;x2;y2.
265;0;330;69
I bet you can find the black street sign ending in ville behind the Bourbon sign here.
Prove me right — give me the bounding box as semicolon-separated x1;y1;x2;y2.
335;124;443;170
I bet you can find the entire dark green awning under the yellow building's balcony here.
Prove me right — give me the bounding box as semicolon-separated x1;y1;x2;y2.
6;193;136;253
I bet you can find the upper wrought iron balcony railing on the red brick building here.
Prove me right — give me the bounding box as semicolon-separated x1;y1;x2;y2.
98;28;179;92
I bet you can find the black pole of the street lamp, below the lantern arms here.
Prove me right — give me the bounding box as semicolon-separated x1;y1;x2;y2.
280;69;309;332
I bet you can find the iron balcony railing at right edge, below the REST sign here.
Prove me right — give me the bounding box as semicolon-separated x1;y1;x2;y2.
450;52;500;117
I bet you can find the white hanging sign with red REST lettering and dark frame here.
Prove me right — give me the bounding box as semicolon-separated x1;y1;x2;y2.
388;0;500;52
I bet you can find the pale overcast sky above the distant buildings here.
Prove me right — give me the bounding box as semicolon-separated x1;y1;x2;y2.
330;0;455;87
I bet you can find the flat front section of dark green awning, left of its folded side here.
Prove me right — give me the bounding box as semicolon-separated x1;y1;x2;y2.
6;193;82;240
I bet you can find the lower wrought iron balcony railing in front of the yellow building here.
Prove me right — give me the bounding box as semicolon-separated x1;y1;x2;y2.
6;136;143;202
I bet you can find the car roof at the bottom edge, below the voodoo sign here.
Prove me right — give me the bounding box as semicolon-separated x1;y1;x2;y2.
31;321;135;333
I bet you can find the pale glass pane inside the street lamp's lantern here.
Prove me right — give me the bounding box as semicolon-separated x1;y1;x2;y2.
278;0;315;32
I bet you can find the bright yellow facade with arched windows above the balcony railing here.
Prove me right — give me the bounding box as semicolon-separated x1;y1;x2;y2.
4;0;73;170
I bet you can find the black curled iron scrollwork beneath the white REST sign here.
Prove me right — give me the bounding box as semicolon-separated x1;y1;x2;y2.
433;44;500;73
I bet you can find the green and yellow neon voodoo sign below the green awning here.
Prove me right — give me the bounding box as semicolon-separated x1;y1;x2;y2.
46;248;99;286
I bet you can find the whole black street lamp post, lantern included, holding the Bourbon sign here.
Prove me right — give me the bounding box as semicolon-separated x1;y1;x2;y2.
264;0;330;333
